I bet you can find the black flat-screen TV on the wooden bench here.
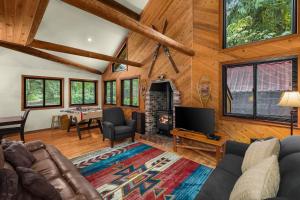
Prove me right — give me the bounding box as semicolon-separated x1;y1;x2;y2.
175;107;215;135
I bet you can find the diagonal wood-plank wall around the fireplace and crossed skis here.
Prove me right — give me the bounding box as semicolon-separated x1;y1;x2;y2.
103;0;193;117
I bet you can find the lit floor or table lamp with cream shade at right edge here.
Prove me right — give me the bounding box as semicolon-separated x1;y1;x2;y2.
278;91;300;135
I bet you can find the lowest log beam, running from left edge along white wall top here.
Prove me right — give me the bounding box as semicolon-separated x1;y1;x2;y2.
0;42;102;74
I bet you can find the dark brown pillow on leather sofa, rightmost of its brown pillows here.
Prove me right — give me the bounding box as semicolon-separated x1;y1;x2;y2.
16;167;61;200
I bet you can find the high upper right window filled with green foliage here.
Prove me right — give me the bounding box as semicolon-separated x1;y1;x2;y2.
223;0;297;48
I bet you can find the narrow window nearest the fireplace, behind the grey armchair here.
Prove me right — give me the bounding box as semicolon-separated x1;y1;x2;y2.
121;78;139;107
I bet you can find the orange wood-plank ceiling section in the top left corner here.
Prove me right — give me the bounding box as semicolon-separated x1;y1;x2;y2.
0;0;49;45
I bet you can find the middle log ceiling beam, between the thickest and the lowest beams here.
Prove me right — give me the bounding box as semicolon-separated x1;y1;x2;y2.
29;40;143;67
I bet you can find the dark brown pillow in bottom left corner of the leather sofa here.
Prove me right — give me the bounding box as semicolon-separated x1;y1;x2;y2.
0;168;18;200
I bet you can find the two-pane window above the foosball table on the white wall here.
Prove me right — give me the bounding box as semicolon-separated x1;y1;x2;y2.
70;79;98;106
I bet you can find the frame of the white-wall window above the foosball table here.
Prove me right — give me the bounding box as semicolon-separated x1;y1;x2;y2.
69;78;98;107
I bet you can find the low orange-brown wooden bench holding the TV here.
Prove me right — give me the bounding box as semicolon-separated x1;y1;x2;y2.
171;129;228;162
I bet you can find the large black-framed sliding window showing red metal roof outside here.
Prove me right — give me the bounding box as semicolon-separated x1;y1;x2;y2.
223;58;297;122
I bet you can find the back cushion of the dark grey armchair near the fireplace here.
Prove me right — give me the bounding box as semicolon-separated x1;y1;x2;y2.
103;108;126;126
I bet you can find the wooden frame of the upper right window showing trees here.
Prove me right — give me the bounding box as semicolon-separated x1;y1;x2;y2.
220;0;300;50
